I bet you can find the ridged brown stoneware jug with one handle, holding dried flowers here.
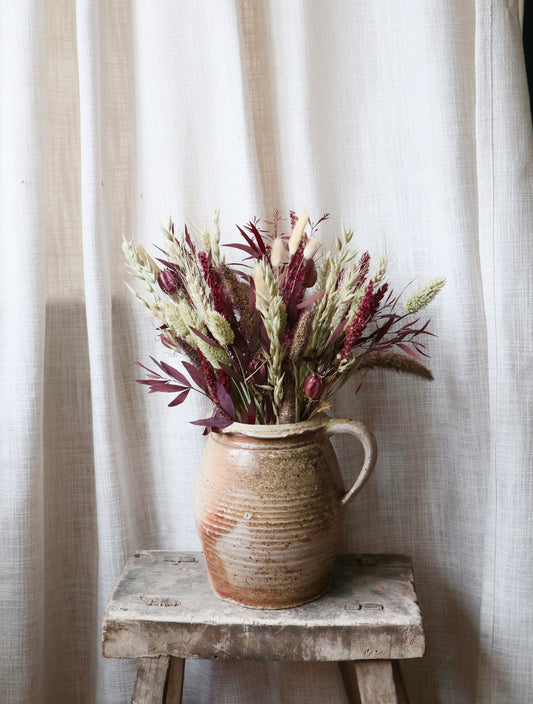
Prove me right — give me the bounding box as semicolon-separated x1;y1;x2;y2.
194;415;377;609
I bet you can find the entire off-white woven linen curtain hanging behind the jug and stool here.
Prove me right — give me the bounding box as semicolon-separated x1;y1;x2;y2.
0;0;533;704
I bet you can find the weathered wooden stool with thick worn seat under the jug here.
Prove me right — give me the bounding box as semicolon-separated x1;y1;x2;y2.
103;550;424;704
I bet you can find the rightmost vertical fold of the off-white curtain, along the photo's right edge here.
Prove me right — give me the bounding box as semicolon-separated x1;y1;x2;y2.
476;2;533;702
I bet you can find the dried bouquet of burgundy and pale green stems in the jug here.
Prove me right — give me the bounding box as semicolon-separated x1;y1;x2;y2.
123;212;444;432
